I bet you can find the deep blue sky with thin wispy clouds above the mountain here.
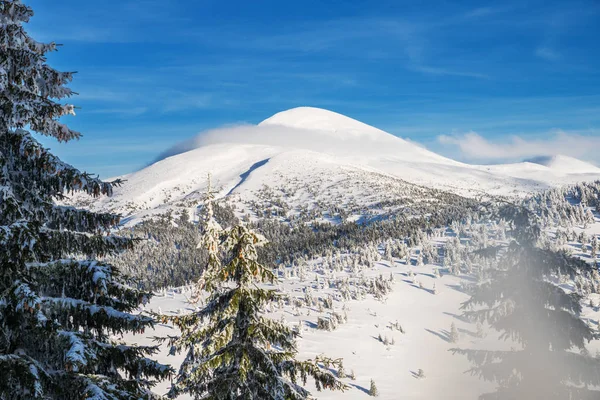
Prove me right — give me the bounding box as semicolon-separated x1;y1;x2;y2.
26;0;600;177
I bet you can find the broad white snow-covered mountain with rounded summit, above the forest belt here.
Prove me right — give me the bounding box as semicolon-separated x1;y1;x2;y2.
81;107;600;220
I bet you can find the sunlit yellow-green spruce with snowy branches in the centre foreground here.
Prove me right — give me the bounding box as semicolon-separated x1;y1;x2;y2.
159;225;345;400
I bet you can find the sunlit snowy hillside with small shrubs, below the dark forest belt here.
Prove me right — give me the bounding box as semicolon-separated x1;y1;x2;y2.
122;219;600;400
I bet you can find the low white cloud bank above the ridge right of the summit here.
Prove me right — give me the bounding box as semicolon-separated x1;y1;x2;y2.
437;130;600;164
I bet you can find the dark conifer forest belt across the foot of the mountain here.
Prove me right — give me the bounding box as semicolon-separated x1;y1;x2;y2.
118;195;477;290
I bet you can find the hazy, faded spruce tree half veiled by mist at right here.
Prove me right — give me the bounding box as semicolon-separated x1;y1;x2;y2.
453;206;600;400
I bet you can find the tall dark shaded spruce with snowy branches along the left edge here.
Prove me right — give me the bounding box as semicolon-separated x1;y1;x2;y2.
0;0;171;400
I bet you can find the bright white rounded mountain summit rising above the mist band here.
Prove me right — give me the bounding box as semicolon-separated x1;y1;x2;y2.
258;107;392;139
